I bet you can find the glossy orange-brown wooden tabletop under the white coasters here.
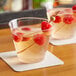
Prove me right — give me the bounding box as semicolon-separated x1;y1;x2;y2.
0;28;76;76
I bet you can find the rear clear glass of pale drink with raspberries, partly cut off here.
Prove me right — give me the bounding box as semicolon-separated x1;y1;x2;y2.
47;5;76;40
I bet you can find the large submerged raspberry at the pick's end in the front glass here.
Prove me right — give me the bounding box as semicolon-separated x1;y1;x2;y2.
34;34;45;45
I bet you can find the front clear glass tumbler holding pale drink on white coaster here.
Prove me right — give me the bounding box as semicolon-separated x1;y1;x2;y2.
9;17;50;63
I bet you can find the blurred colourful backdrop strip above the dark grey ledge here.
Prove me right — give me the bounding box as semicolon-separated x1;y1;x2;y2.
0;0;76;13
